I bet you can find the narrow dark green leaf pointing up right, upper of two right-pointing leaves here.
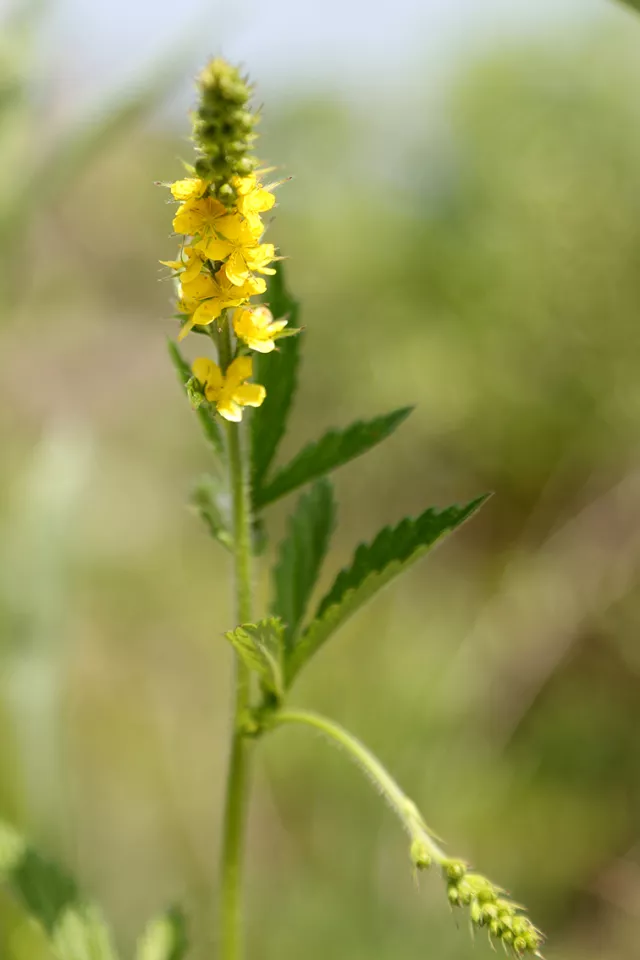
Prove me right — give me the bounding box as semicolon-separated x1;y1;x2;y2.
254;407;413;510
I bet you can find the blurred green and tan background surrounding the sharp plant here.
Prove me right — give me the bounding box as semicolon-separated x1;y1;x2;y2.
0;0;640;960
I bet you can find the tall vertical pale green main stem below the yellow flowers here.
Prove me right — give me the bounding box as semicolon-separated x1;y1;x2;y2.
218;318;252;960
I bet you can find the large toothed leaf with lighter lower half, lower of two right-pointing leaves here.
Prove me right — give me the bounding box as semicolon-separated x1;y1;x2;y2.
286;495;487;683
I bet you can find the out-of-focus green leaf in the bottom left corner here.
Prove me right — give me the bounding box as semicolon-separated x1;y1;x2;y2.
0;822;116;960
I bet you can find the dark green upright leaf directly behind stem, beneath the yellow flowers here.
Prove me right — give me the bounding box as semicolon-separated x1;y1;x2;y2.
251;261;304;490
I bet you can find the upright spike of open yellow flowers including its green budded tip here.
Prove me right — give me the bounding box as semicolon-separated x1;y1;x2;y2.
162;60;287;421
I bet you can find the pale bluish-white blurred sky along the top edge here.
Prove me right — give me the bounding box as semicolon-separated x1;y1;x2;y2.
47;0;628;113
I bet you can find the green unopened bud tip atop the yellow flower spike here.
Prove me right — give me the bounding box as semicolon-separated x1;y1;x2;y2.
193;59;258;207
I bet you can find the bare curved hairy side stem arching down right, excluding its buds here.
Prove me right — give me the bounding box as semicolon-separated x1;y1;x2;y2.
271;710;448;864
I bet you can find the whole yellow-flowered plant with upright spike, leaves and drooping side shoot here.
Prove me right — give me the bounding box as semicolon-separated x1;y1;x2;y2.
163;54;542;960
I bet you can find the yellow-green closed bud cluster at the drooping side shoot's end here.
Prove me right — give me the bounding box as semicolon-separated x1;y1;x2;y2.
441;859;543;957
